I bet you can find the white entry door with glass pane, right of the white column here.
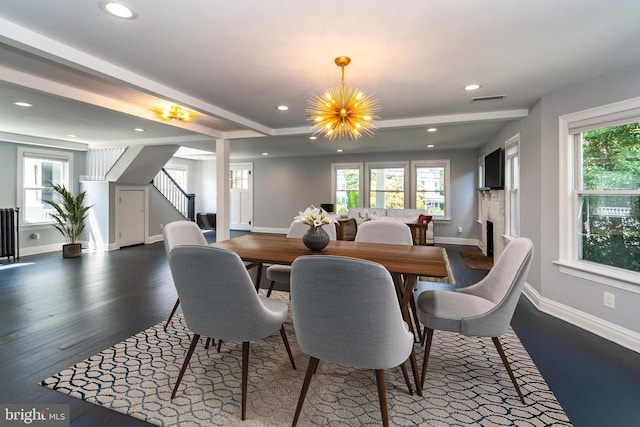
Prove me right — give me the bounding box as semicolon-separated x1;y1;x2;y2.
229;163;253;231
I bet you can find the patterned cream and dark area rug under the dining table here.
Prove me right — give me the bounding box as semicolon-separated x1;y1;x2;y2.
41;291;570;427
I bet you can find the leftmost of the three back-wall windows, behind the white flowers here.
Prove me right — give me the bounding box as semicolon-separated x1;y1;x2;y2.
331;163;362;214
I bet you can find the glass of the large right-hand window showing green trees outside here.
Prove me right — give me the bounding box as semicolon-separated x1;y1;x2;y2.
575;123;640;272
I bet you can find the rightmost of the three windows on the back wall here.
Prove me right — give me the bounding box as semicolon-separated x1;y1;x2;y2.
411;160;449;218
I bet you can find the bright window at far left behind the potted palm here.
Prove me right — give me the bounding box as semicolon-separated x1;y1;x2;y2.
18;148;72;224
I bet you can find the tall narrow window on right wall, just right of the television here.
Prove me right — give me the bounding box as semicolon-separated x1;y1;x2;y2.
505;135;520;237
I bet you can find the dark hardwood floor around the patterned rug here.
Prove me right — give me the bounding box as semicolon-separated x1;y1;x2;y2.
0;236;640;427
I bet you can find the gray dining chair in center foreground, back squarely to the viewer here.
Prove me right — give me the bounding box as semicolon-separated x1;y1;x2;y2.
291;255;415;426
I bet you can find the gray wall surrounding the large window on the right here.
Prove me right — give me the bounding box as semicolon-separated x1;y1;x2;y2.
481;63;640;338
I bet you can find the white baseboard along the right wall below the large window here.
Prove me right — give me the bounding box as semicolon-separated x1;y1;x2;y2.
523;283;640;353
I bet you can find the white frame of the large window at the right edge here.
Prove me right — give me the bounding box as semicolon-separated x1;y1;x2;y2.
555;97;640;293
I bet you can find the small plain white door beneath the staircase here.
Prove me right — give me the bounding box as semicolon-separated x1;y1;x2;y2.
117;188;146;247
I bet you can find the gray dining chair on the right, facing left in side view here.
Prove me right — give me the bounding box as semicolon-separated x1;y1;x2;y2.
417;237;533;404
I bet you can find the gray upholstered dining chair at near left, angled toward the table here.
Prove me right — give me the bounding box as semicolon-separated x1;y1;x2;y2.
171;246;296;420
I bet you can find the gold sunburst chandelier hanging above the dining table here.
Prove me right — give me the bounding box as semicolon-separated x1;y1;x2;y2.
307;56;380;140
